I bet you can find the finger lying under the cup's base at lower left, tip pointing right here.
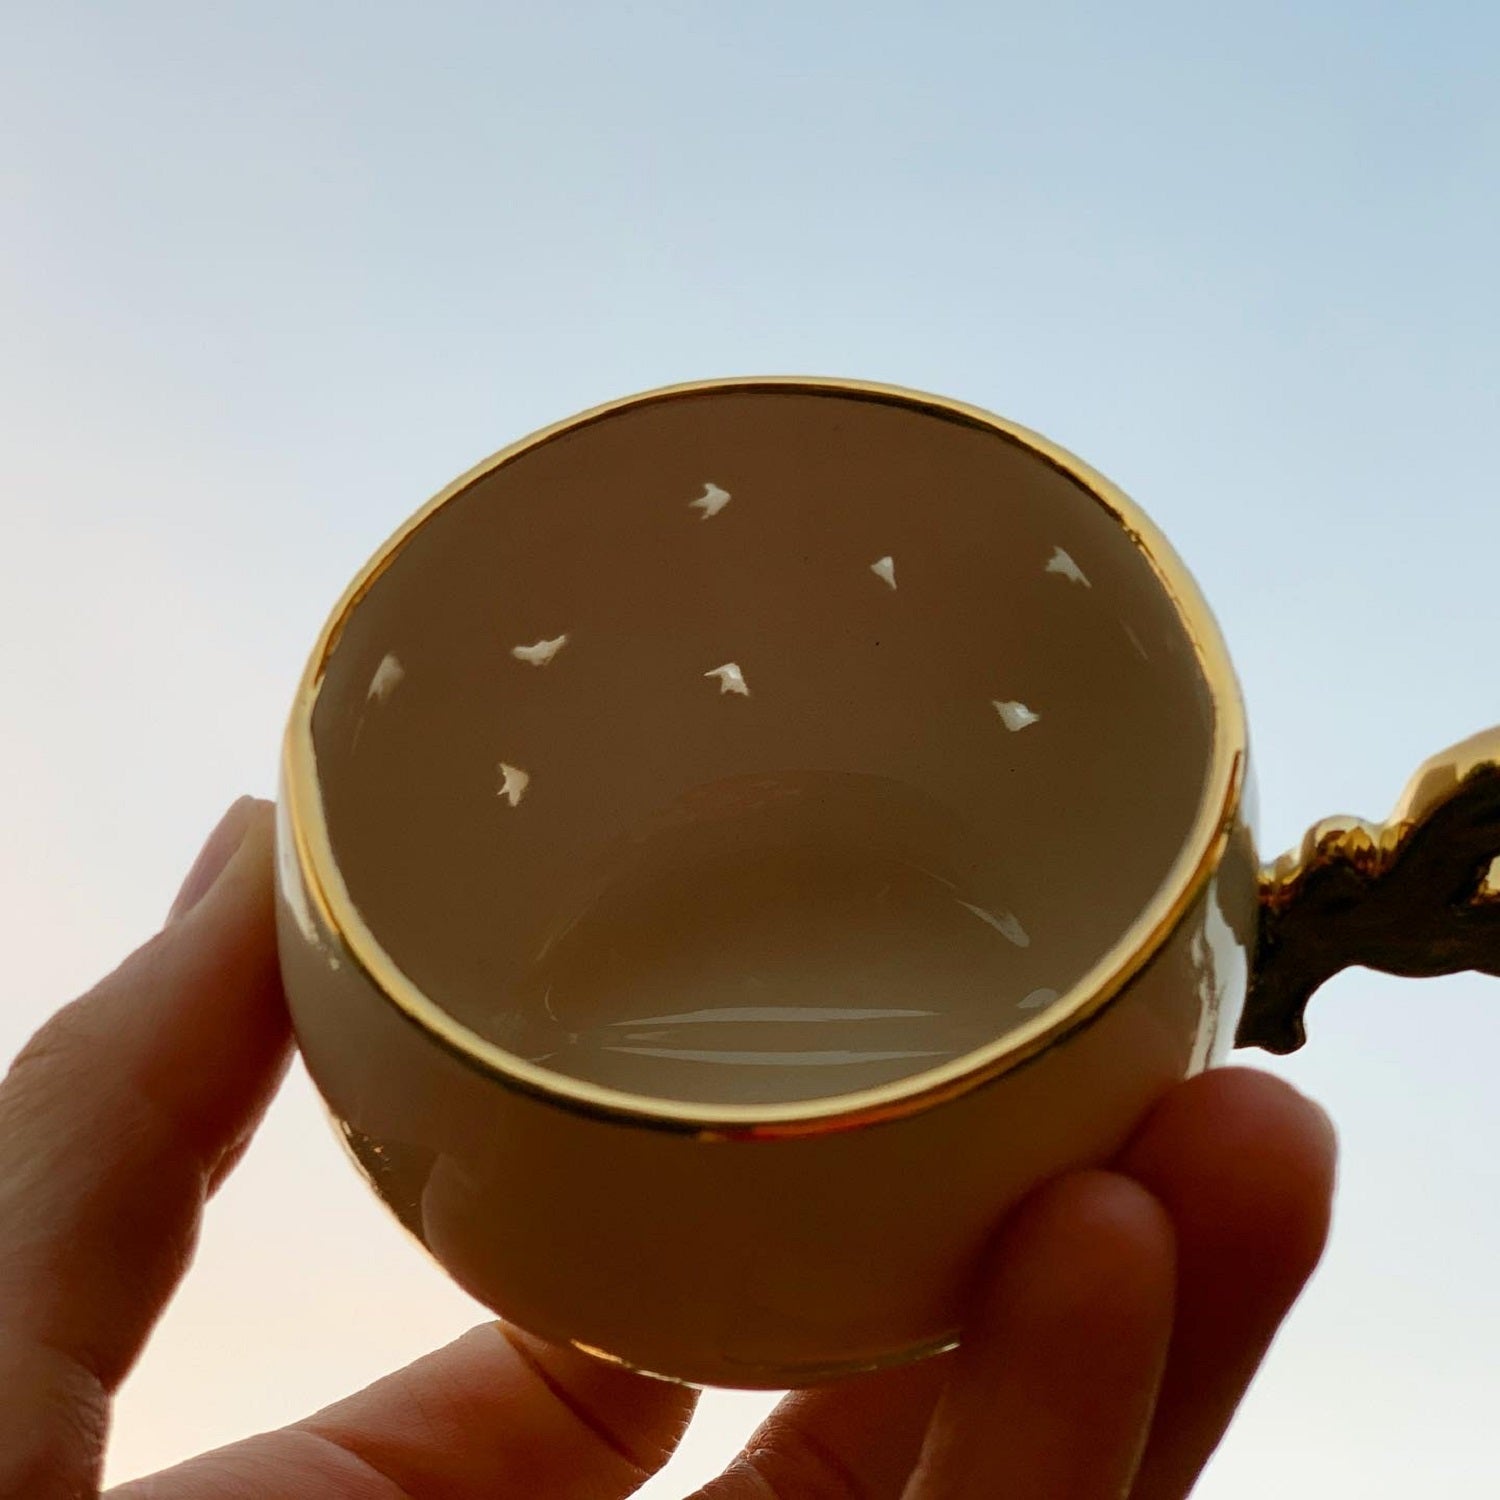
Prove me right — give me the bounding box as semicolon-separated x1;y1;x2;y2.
110;1323;695;1500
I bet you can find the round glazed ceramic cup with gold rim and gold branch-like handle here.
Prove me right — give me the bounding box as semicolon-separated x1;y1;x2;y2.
279;380;1500;1388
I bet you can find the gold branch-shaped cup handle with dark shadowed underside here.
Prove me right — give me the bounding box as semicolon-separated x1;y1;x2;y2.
1236;729;1500;1052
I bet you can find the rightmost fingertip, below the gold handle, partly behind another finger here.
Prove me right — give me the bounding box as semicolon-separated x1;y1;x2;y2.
1118;1068;1337;1500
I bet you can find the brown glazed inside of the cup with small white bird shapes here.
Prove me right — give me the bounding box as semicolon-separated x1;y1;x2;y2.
311;386;1215;1106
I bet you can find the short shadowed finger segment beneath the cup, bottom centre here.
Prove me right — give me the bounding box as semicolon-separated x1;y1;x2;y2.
693;1356;950;1500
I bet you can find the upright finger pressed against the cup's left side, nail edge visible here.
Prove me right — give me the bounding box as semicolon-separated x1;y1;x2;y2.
0;800;288;1500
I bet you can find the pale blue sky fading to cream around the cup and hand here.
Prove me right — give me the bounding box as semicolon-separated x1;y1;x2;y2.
0;0;1500;1500
